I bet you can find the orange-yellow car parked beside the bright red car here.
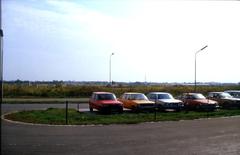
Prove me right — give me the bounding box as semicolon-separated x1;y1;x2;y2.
119;93;155;111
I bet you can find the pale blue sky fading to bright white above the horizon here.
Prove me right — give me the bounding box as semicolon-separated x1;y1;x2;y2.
2;0;240;82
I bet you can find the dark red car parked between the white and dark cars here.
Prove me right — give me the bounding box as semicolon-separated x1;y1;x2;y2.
180;93;219;111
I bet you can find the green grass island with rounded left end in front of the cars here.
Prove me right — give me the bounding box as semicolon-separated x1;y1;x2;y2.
5;108;240;125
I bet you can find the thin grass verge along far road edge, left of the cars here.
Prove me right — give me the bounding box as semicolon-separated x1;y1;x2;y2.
3;98;89;104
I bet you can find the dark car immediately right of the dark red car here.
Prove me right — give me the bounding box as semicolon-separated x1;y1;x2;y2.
208;92;240;108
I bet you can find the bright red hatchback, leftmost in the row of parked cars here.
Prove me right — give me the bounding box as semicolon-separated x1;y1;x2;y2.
89;92;123;113
